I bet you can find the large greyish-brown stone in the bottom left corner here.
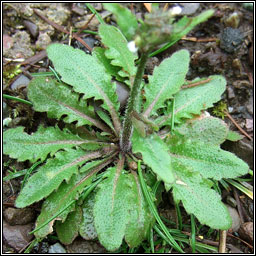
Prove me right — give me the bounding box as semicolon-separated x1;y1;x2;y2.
3;221;33;251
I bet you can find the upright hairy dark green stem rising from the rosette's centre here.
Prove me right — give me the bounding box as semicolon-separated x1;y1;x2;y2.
120;53;148;152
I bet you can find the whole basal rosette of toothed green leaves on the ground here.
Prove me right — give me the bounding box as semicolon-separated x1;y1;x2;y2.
3;5;248;251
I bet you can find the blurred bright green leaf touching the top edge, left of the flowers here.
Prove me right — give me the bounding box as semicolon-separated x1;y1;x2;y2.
103;3;138;41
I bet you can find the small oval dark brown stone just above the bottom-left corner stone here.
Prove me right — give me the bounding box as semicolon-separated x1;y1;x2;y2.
4;207;36;225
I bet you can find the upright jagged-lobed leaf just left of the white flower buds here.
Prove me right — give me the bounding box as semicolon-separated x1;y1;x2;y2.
99;24;137;77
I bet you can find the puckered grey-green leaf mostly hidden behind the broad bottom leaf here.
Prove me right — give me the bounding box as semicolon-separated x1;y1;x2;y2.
79;192;97;240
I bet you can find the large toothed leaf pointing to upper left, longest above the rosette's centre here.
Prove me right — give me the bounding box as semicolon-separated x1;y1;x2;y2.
47;44;121;132
